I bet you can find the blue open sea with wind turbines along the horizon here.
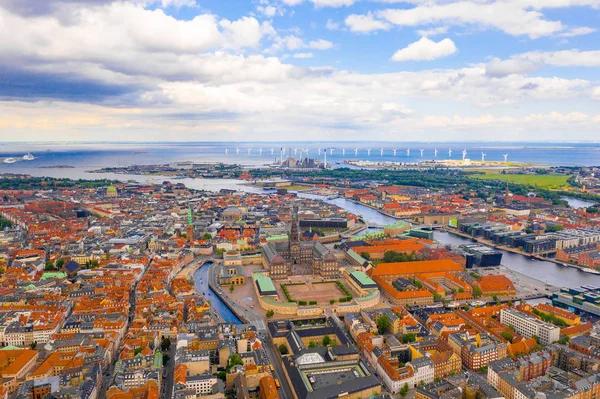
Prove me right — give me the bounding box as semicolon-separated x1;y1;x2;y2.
0;142;600;179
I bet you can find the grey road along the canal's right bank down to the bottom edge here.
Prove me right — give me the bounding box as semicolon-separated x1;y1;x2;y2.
208;260;294;399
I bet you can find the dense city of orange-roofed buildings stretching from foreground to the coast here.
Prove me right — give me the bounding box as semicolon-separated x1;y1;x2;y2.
0;154;600;399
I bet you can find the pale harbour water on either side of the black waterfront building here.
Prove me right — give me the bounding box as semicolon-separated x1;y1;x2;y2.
434;231;600;288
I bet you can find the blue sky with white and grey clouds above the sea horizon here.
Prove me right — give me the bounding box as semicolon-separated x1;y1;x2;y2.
0;0;600;142
